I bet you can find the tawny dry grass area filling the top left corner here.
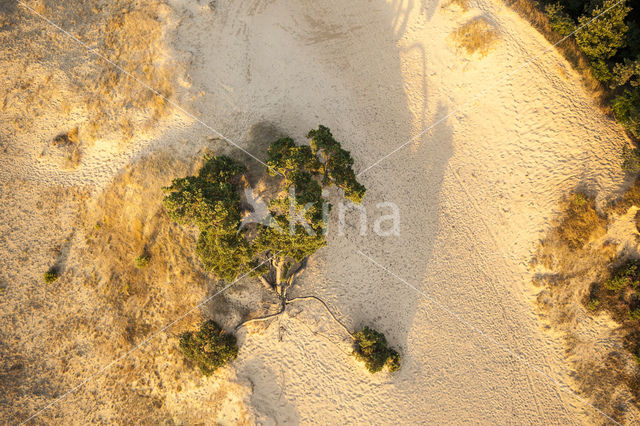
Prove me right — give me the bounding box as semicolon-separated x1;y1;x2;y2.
0;0;175;167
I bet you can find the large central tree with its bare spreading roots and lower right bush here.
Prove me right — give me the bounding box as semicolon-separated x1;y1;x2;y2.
163;125;399;371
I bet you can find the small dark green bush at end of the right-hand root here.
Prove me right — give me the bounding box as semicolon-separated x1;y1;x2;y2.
353;326;400;373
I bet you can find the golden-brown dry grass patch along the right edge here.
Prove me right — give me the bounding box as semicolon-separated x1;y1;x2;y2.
533;191;640;423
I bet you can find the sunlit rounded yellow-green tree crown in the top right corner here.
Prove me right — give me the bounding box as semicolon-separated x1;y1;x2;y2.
575;0;631;60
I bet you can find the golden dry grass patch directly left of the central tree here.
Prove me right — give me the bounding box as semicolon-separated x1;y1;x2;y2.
84;153;207;336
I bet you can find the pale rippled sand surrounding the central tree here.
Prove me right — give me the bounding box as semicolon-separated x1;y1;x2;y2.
0;0;628;424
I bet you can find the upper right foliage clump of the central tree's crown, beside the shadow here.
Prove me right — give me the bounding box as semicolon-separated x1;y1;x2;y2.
307;125;366;203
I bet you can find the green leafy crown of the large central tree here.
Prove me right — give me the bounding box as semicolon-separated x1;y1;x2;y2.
163;126;365;284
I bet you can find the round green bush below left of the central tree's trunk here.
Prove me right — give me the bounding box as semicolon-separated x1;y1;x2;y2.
180;320;238;376
